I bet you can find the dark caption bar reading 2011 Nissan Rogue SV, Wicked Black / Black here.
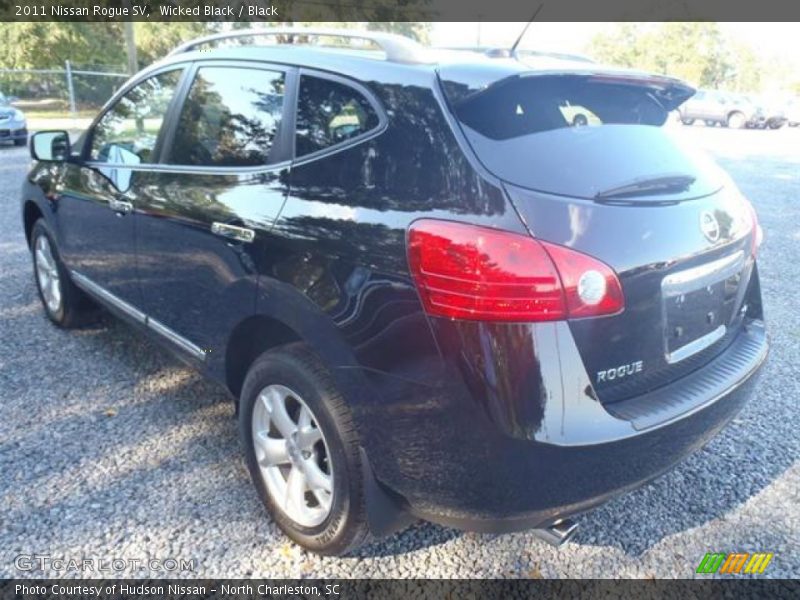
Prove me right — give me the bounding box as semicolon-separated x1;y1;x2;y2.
0;0;800;22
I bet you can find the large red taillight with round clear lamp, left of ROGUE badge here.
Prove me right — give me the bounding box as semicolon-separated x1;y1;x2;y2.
408;219;624;321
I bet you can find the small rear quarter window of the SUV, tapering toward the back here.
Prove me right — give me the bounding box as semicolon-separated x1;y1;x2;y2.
295;75;380;156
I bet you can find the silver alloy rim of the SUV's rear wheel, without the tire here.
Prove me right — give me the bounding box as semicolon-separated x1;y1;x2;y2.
252;384;334;527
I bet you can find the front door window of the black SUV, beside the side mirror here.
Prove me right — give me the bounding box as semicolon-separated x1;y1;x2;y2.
90;70;182;165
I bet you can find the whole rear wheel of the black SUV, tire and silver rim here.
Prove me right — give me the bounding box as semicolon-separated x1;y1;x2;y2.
239;343;369;555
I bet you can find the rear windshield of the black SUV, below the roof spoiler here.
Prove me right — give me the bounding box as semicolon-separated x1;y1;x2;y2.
454;74;719;200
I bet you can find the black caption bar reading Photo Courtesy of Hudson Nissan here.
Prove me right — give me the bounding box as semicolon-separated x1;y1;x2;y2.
0;579;800;600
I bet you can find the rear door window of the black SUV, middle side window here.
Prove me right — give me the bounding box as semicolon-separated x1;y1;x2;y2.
170;67;284;167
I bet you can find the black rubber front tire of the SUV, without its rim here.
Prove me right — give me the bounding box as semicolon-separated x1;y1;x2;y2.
31;219;96;329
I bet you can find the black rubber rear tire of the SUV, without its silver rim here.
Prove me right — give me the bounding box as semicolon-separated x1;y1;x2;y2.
239;343;369;556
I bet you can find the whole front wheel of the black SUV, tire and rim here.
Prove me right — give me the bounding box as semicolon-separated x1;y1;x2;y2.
31;219;93;328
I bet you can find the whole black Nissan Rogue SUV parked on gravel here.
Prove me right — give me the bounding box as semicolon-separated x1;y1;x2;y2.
22;29;767;554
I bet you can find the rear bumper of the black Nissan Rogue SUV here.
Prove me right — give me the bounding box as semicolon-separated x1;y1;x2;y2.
350;322;768;532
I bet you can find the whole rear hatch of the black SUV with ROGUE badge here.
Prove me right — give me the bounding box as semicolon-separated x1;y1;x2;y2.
440;71;754;402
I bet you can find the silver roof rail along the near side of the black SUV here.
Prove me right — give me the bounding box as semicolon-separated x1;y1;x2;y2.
169;27;432;64
